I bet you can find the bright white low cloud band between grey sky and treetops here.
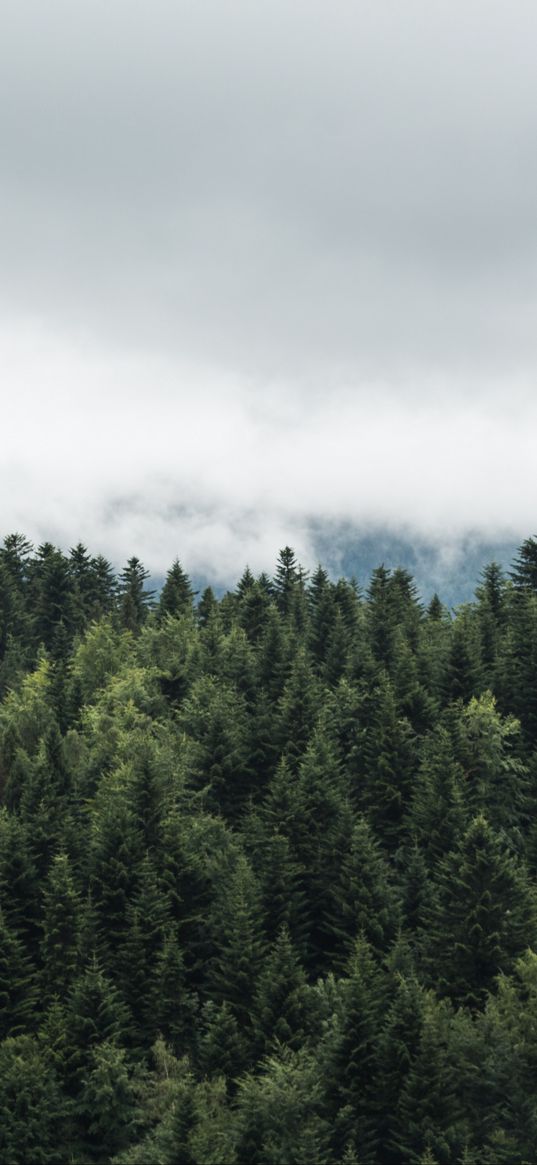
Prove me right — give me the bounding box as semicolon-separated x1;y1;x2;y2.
0;323;537;581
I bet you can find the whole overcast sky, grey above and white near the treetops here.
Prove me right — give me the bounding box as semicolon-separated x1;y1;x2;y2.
0;0;537;581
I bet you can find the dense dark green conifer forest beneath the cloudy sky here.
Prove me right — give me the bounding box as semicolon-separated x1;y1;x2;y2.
0;534;537;1165
